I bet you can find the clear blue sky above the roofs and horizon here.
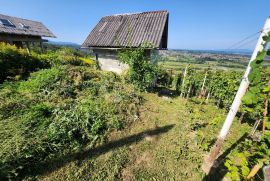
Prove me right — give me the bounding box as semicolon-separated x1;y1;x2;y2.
0;0;270;50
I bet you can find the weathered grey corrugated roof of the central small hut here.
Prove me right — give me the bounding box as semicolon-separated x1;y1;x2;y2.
82;11;169;48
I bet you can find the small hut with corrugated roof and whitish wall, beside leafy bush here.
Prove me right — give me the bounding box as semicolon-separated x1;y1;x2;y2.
82;11;169;73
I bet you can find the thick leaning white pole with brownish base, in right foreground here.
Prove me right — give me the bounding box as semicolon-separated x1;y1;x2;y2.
202;17;270;174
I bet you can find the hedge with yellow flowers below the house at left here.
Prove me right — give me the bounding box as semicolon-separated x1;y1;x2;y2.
0;42;96;83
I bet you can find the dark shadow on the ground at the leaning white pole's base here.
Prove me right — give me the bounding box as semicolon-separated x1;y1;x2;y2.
203;133;248;181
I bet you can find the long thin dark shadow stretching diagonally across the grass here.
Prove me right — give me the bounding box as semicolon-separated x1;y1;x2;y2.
23;125;174;177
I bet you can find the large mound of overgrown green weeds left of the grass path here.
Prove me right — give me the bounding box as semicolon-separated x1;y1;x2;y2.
0;65;140;179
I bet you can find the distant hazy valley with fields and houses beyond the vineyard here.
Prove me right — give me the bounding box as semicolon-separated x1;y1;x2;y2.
160;50;270;72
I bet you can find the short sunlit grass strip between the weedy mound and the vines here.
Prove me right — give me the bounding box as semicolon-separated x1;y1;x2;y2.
38;93;249;180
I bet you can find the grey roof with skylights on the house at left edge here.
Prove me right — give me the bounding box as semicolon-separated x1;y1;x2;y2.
0;14;56;38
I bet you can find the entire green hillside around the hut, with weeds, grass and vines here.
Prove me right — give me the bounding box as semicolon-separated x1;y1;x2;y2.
0;43;270;180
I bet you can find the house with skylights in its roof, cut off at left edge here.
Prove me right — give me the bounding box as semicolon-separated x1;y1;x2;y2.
0;14;55;50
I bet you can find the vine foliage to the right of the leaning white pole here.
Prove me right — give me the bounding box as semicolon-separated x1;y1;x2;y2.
225;34;270;180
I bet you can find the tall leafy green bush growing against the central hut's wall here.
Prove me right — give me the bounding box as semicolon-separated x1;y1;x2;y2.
118;43;158;90
